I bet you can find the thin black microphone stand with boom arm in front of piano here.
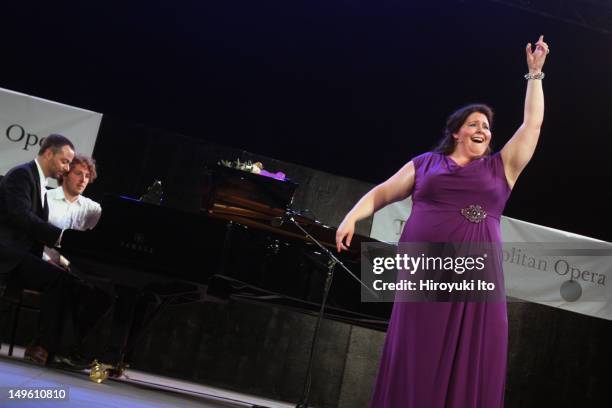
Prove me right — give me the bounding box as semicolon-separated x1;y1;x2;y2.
281;210;378;408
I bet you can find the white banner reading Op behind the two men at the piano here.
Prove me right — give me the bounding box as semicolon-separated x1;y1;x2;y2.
0;88;102;175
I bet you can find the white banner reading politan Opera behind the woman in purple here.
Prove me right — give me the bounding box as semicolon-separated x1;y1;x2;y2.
370;199;612;320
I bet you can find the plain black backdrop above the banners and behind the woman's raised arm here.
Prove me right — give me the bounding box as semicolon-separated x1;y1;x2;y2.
0;0;612;241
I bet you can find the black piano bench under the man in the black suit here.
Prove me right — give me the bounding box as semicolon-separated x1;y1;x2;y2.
0;283;41;356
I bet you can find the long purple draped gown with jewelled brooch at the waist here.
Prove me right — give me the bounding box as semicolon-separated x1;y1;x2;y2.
370;153;510;408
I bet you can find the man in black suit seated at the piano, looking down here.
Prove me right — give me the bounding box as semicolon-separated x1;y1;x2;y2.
0;134;74;365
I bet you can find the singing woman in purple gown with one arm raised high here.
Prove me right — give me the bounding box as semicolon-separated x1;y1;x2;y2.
336;36;549;408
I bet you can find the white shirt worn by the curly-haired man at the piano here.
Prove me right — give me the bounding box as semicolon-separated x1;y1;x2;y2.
43;186;102;262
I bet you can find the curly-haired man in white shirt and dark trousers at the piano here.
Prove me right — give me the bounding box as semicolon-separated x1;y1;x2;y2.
43;154;146;368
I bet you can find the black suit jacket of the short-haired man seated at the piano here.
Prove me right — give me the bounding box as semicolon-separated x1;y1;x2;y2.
0;161;62;279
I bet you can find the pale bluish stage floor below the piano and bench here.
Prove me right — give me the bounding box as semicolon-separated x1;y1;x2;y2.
0;345;295;408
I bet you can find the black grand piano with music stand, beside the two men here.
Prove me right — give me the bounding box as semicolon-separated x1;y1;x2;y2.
61;166;391;338
